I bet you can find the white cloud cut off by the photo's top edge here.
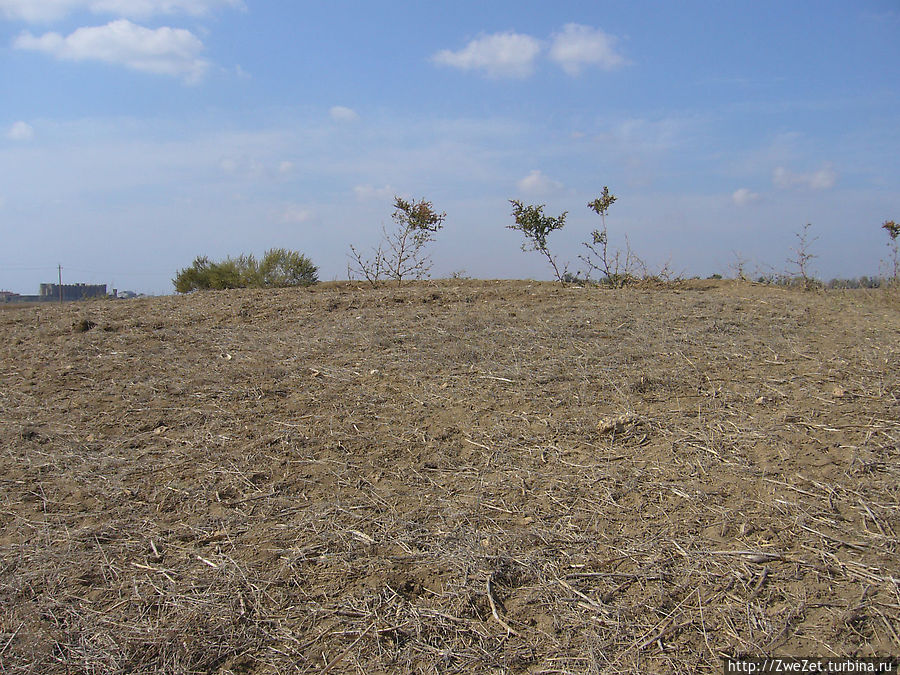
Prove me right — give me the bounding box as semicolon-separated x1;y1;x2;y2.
0;0;244;22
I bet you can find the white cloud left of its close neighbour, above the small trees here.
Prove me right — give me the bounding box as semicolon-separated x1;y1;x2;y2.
431;31;542;78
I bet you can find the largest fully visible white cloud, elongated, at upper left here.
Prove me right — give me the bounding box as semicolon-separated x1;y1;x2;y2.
13;19;209;83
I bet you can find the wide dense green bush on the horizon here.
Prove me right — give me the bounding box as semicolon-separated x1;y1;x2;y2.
172;248;319;293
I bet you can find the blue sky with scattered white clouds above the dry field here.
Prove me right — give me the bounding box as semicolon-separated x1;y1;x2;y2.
0;0;900;293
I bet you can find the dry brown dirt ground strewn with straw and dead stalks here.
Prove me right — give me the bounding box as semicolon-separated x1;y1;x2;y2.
0;281;900;674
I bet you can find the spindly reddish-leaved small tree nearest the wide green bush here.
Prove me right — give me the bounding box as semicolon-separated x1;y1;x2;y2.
347;197;447;286
